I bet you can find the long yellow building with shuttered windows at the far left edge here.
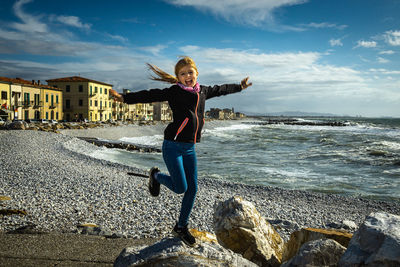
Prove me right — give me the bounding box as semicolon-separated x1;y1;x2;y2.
0;77;63;120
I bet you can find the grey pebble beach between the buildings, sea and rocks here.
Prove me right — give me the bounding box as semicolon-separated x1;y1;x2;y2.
0;122;400;240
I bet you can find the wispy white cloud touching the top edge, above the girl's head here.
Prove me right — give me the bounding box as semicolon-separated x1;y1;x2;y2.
165;0;308;30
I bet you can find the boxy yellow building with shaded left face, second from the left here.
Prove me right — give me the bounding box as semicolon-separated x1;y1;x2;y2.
47;76;112;121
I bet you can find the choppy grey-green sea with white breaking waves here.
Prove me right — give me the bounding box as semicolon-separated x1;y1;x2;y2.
89;118;400;201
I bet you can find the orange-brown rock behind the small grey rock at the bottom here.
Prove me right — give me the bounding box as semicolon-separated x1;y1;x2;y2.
282;228;353;261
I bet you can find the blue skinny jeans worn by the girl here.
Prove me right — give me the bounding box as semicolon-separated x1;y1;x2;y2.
156;140;197;227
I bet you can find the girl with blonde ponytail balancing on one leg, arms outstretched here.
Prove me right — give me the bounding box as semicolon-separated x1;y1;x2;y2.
110;57;252;246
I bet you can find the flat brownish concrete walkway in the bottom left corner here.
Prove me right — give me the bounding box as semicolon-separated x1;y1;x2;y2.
0;233;157;267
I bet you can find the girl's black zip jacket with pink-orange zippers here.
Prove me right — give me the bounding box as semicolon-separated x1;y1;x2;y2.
124;84;242;143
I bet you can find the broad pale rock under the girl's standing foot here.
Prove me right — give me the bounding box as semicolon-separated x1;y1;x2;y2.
114;236;257;267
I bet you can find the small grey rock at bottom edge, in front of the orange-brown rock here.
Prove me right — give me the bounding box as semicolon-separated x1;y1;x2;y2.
281;239;346;267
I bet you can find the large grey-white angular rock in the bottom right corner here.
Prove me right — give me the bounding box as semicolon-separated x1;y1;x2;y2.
339;212;400;267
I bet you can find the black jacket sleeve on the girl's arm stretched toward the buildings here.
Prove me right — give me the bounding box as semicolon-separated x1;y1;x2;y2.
124;88;170;104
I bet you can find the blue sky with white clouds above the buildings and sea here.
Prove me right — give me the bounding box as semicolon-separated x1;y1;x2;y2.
0;0;400;117
